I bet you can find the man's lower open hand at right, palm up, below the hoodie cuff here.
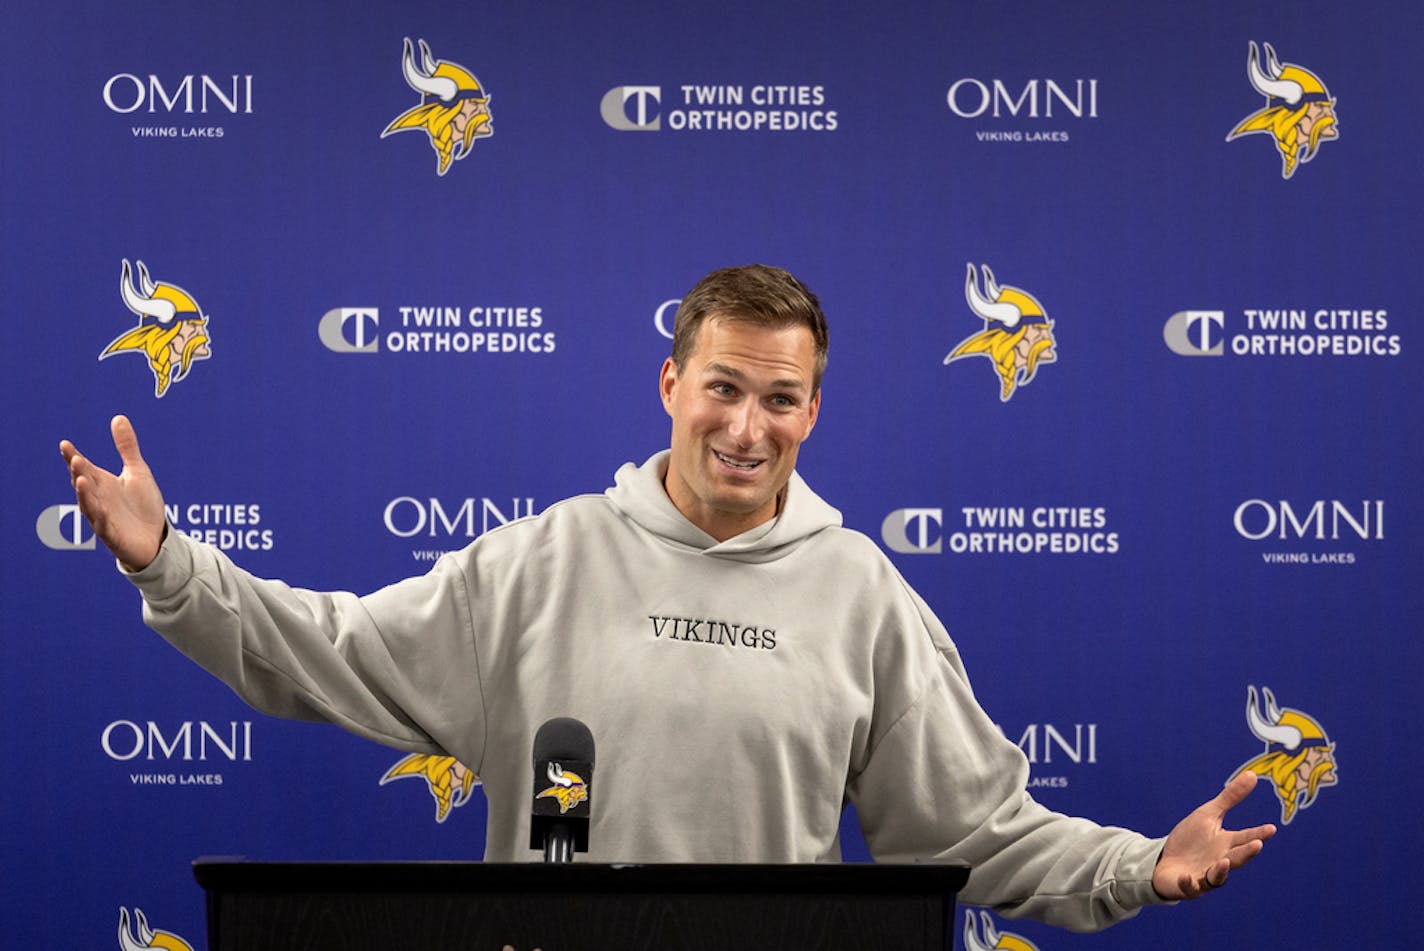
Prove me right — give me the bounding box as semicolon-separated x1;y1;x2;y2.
1152;772;1276;900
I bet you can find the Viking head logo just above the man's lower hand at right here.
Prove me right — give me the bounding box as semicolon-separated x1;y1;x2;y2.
1233;686;1336;826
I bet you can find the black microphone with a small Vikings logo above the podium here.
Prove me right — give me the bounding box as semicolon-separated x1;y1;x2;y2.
530;716;594;863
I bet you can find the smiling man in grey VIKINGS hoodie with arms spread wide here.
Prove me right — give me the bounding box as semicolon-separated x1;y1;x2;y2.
60;266;1274;930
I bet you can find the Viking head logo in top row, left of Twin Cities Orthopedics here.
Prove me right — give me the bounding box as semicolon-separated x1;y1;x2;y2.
380;37;494;175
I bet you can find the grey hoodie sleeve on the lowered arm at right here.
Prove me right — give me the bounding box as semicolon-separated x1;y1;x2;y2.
849;588;1162;931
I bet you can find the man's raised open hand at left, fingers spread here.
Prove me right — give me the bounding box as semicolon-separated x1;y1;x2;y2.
60;416;168;571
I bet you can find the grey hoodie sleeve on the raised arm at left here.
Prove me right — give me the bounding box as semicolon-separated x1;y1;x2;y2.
127;531;484;769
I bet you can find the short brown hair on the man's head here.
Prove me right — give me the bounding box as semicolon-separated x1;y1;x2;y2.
672;265;830;393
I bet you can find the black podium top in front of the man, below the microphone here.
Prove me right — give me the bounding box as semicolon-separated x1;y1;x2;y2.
194;858;968;951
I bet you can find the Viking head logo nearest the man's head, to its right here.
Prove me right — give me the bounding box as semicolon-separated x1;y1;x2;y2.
944;263;1058;403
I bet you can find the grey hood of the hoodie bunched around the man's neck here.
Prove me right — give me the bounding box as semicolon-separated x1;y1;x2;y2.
604;450;840;562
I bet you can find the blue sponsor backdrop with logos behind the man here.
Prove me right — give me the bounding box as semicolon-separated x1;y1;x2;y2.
0;0;1424;951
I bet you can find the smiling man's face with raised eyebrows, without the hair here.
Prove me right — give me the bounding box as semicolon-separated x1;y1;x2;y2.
659;316;820;541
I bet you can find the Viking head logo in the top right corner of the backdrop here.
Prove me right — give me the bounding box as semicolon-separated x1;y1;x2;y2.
1226;41;1340;178
